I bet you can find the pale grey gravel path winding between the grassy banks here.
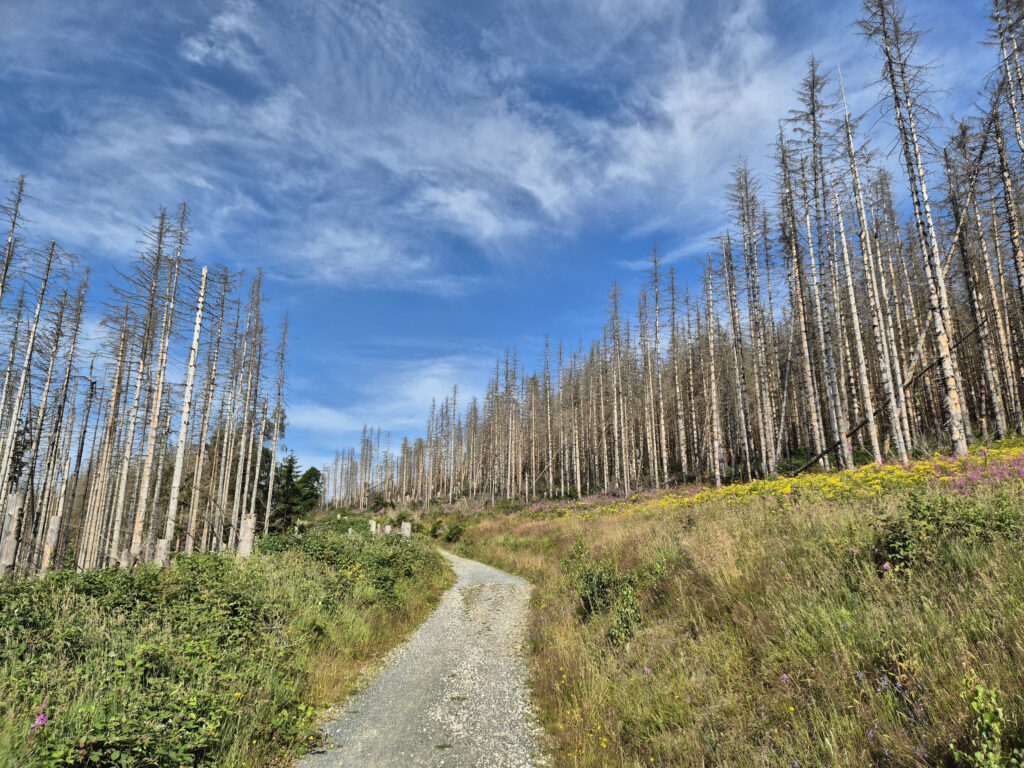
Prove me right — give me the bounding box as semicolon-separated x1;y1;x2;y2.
299;553;546;768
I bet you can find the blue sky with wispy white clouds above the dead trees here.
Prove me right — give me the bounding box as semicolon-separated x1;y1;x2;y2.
0;0;995;473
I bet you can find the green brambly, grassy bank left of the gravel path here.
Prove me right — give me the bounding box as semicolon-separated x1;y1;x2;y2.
0;520;451;768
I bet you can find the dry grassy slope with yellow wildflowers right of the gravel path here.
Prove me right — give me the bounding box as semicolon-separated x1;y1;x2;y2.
450;441;1024;766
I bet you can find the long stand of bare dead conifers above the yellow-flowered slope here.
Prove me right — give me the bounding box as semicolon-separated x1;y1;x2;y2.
323;0;1024;508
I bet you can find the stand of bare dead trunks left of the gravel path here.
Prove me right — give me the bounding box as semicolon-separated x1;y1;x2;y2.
0;188;288;575
